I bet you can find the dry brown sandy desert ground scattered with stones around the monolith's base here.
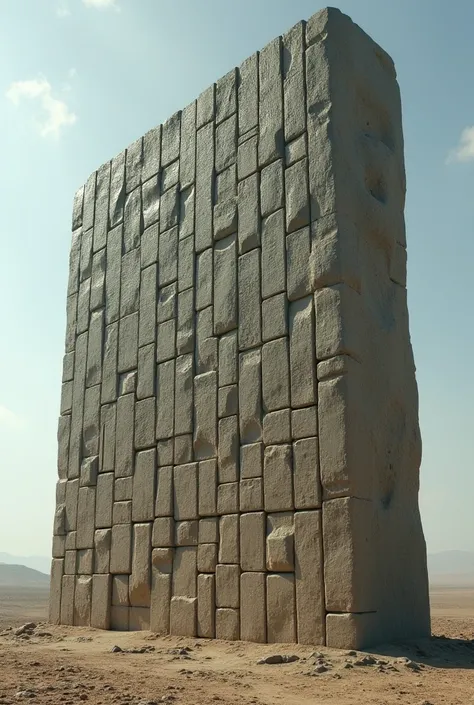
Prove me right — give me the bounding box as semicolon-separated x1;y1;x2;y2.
0;585;474;705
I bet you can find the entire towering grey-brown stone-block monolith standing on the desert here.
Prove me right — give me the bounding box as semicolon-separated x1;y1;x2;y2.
50;9;429;648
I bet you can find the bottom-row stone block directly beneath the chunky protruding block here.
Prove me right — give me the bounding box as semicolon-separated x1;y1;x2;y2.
267;573;296;644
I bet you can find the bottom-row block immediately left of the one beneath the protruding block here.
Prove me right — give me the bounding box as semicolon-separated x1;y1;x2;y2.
240;573;267;644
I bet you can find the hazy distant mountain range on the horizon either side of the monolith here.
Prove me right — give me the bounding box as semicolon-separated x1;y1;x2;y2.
0;542;474;587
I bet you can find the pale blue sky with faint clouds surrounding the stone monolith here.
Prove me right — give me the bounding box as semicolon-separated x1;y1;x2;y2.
0;0;474;555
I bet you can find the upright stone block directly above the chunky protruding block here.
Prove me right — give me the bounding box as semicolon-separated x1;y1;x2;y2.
263;444;293;512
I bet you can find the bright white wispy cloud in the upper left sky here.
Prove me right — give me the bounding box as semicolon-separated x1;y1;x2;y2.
5;77;77;137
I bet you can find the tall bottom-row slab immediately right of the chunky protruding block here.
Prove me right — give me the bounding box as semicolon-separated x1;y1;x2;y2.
295;511;326;644
